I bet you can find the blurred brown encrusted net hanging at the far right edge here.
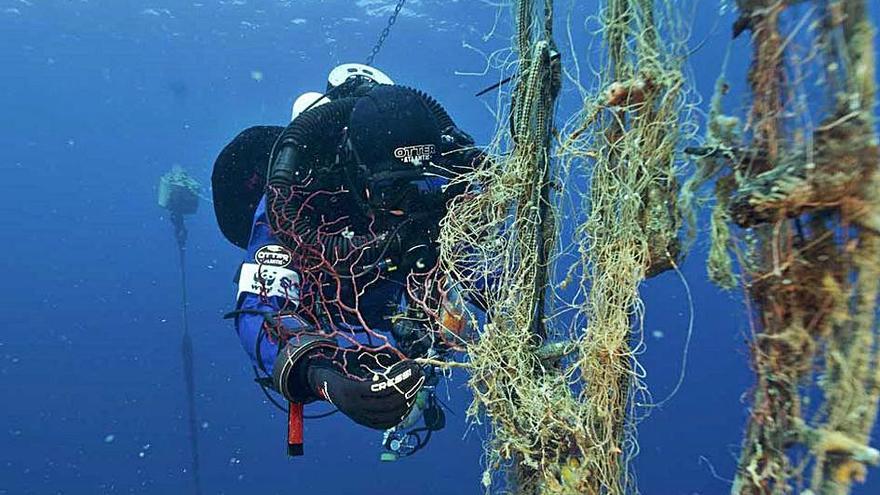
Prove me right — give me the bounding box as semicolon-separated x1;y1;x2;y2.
683;0;880;494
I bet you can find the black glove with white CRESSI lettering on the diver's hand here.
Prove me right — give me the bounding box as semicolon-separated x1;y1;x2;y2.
306;351;425;430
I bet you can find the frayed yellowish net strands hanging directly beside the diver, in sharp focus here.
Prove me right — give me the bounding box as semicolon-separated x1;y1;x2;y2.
438;0;688;494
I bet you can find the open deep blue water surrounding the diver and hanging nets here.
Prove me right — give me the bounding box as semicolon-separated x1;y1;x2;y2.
0;0;880;495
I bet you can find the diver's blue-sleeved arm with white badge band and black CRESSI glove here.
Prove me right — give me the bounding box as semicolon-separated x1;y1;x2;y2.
230;213;424;430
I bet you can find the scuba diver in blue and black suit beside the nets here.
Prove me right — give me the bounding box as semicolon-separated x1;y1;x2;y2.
212;64;484;459
